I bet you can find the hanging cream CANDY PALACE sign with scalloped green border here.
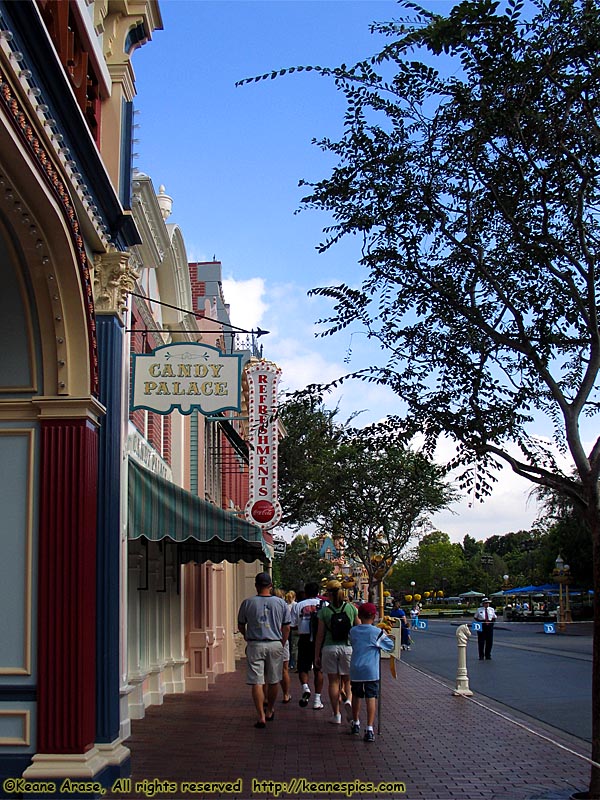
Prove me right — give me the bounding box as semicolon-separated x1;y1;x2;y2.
131;342;242;414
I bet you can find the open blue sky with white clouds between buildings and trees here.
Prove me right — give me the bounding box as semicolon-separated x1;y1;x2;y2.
133;0;548;542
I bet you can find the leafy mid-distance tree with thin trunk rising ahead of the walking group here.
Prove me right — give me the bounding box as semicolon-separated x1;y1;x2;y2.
326;438;455;598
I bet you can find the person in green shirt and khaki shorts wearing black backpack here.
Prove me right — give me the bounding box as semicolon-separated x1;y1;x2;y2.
315;580;358;725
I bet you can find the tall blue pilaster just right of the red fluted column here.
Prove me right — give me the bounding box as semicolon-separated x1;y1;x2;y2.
96;315;123;743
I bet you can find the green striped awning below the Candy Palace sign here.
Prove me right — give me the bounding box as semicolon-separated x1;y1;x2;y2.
127;458;271;563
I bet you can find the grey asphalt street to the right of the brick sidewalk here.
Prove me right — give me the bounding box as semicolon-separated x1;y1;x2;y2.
403;619;592;741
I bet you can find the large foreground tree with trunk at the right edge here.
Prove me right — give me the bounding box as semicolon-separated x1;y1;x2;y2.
243;0;600;798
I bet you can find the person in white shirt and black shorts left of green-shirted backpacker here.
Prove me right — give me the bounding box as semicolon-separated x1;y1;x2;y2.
292;581;327;711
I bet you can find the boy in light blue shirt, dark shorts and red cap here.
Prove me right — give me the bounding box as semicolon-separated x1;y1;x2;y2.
348;603;394;742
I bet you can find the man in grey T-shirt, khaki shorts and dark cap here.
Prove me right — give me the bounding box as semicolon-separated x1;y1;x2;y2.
238;572;291;728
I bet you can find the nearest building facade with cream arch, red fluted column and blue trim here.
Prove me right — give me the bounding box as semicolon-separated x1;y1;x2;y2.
0;0;162;788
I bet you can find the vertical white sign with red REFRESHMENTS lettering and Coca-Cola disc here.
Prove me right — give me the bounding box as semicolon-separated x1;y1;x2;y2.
244;361;282;530
